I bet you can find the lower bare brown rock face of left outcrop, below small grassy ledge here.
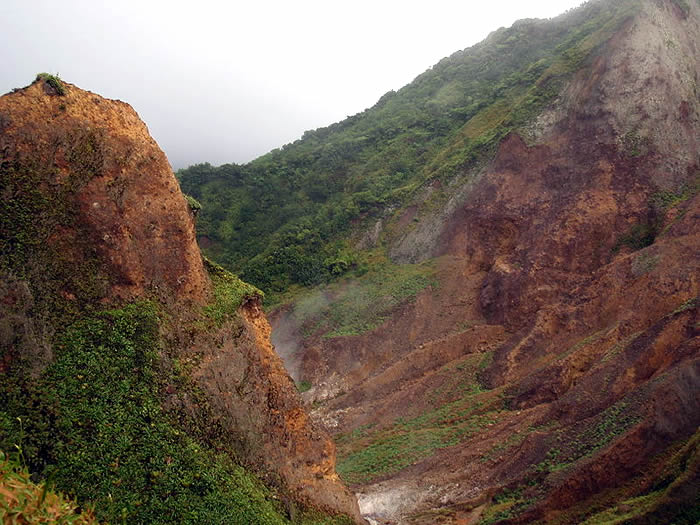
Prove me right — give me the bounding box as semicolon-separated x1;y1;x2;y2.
193;301;362;522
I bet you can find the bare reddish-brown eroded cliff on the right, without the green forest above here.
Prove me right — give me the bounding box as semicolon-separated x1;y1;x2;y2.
266;0;700;523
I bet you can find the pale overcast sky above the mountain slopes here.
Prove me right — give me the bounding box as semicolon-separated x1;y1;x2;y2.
0;0;582;169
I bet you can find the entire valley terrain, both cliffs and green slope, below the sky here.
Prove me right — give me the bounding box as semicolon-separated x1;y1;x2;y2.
0;0;700;525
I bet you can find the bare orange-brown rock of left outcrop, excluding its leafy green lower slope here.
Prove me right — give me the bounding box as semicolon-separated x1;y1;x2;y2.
0;78;362;522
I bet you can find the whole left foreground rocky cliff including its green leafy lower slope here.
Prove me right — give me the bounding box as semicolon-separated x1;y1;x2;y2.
0;75;361;523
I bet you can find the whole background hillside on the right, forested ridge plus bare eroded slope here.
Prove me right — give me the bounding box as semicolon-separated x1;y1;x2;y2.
181;0;700;524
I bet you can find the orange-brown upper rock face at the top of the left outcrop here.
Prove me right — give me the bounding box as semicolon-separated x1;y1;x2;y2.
0;82;209;304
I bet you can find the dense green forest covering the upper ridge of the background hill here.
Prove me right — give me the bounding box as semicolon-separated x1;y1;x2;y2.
178;0;634;301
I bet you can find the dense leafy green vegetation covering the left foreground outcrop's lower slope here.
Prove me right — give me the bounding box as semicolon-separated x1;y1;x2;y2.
0;303;286;524
